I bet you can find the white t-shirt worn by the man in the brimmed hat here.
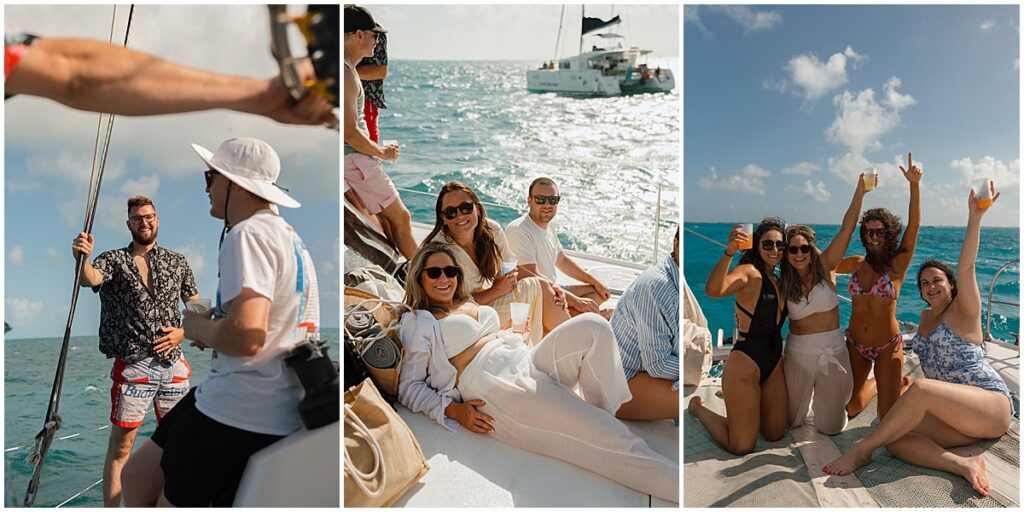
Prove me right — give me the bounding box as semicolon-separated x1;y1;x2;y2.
196;210;319;435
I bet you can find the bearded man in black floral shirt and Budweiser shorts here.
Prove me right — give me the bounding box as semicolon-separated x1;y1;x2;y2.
72;196;200;507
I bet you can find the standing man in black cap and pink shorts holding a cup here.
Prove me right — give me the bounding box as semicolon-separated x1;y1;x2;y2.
344;6;417;260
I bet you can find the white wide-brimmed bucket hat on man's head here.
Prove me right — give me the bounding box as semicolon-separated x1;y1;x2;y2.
191;137;302;208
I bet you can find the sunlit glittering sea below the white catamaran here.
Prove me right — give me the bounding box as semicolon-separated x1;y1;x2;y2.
379;58;681;264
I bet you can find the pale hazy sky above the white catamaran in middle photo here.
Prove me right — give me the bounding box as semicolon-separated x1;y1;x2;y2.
368;4;680;60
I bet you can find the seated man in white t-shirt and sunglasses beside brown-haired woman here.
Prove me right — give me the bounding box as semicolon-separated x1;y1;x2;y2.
505;177;611;318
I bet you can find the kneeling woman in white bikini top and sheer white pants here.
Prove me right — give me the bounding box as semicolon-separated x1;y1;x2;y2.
779;174;866;435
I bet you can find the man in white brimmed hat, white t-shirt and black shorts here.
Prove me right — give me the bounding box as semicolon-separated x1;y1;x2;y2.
124;138;319;507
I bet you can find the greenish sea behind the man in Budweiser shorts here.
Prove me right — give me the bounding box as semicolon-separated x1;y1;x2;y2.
4;327;340;507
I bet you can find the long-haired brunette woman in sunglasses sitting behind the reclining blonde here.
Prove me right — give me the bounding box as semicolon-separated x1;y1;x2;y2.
424;181;569;344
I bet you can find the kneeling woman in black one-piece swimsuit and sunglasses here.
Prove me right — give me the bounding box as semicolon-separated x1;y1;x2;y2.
689;218;788;455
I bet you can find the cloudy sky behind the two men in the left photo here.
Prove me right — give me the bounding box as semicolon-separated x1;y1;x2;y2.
4;5;340;338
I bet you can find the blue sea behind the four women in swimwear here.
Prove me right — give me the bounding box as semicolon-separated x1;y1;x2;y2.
683;222;1020;342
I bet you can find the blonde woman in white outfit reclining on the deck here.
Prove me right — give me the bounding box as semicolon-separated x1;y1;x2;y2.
398;243;679;503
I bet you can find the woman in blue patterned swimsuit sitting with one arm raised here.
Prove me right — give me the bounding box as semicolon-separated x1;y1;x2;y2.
823;187;1013;496
